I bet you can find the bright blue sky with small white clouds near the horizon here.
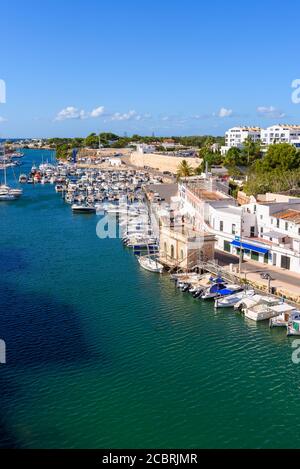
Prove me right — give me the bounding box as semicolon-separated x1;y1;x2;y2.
0;0;300;137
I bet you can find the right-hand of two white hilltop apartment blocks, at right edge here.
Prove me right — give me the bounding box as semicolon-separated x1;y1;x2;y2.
261;124;300;147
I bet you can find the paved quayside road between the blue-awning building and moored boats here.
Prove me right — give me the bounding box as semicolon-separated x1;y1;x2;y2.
215;251;300;291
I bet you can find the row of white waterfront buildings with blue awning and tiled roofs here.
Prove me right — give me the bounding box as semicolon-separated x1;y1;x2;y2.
179;183;300;273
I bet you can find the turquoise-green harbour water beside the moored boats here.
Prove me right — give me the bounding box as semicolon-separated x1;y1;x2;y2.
0;151;300;448
